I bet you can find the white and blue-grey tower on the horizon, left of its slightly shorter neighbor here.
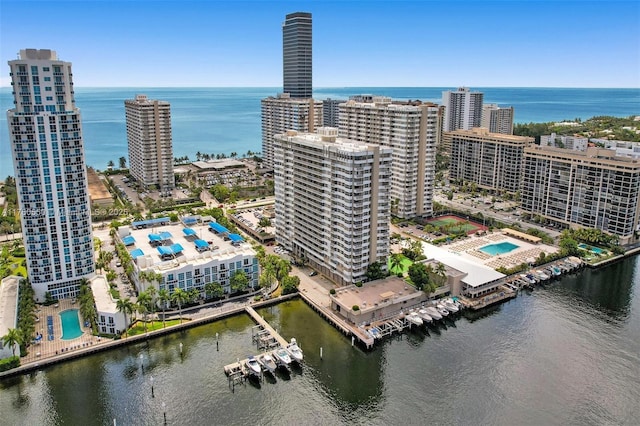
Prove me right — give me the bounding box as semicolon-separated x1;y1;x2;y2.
442;87;484;132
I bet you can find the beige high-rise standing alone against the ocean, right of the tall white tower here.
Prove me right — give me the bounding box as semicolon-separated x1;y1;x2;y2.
124;95;175;192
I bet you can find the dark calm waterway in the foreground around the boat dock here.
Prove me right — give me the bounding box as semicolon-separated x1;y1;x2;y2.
0;257;640;425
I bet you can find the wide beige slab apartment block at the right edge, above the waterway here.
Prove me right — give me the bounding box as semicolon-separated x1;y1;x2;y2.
521;145;640;244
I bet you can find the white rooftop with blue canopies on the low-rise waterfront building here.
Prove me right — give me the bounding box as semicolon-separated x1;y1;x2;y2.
118;216;255;270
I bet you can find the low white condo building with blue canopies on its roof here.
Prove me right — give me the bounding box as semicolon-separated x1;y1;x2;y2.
118;216;258;295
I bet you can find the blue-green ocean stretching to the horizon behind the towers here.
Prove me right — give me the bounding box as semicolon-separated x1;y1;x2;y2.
0;87;640;178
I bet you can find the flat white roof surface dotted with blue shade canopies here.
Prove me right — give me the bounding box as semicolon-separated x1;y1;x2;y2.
120;220;255;269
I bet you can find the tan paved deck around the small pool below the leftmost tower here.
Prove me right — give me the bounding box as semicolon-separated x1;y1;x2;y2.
20;299;104;364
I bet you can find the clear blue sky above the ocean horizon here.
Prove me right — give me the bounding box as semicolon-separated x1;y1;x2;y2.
0;0;640;88
